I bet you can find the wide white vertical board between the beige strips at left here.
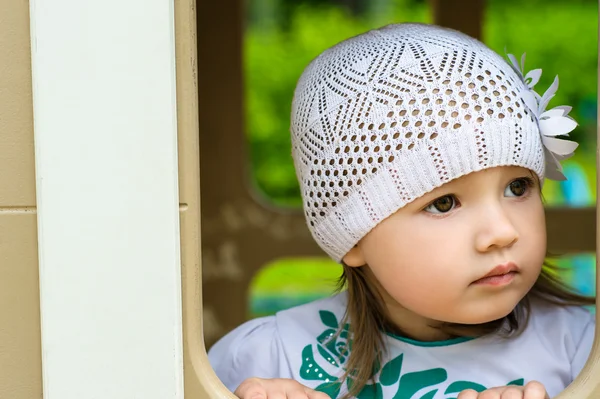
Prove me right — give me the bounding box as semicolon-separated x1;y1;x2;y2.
30;0;183;399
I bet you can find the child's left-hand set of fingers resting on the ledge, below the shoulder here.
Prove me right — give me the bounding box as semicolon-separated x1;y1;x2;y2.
234;378;330;399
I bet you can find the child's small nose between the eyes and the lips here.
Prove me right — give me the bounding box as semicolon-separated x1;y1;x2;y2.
475;206;519;252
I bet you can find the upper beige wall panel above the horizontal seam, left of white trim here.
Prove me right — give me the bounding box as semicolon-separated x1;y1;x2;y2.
0;0;35;208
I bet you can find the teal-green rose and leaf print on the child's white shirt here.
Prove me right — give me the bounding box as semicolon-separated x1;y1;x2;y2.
300;310;524;399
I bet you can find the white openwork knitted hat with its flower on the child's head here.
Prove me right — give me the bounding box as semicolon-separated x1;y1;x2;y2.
291;24;576;261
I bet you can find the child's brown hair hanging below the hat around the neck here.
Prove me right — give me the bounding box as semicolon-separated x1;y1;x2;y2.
338;262;595;399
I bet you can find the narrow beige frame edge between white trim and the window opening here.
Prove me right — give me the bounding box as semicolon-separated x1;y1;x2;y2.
175;0;235;398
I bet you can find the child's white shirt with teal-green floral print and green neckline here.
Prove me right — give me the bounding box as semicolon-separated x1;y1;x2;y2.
208;293;595;399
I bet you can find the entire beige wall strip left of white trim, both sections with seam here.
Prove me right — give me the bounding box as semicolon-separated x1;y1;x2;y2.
0;0;42;399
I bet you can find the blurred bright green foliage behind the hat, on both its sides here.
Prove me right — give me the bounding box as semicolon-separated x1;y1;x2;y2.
244;0;598;206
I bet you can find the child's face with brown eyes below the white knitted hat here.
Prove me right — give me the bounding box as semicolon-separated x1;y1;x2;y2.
344;166;546;338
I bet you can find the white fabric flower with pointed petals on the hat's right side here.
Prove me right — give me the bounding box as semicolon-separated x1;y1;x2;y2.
508;54;579;180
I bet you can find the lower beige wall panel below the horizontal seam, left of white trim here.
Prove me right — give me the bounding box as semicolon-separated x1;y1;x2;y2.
0;214;42;399
